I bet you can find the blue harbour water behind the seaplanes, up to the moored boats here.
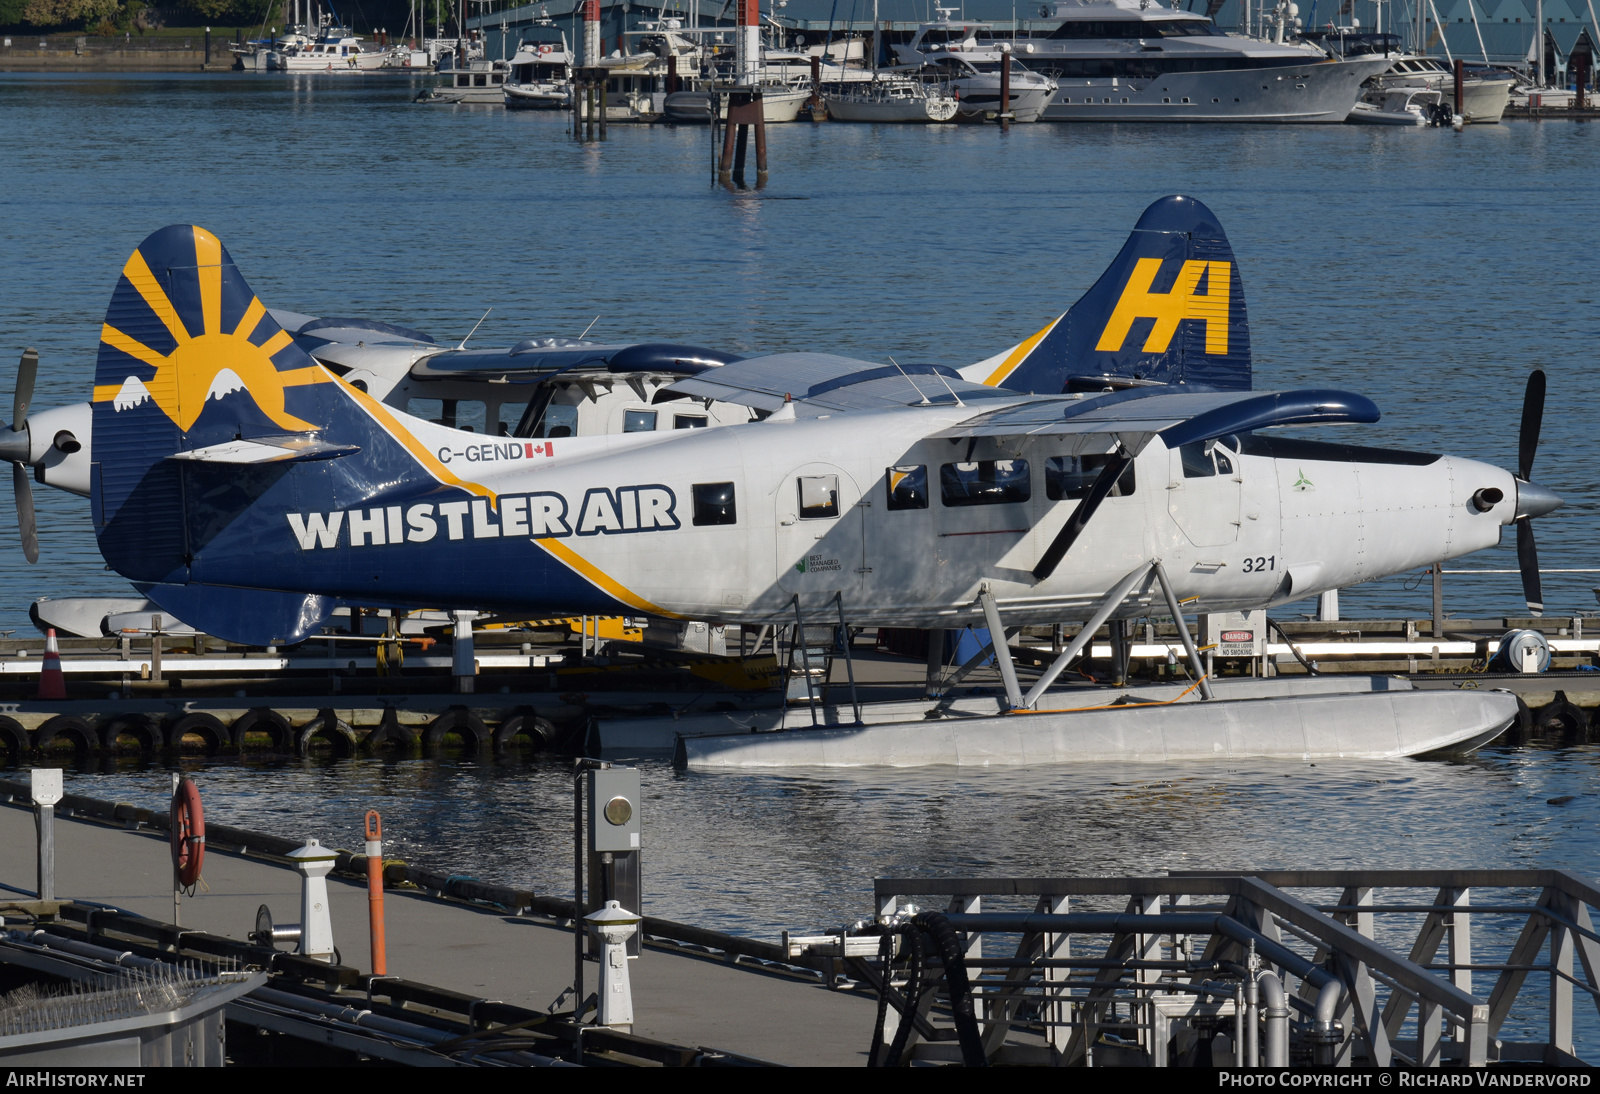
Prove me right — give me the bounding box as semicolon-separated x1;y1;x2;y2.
0;74;1600;630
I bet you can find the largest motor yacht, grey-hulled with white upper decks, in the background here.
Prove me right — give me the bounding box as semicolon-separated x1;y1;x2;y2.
1014;0;1389;123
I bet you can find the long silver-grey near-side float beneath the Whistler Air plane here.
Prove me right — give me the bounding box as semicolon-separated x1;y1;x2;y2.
675;689;1517;769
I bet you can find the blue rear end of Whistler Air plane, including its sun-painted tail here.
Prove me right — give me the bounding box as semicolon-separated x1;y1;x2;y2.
90;226;636;645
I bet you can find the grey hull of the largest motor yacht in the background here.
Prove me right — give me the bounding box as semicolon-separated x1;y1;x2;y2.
1029;58;1389;125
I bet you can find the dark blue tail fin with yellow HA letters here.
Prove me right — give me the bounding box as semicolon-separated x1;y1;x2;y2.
976;195;1250;395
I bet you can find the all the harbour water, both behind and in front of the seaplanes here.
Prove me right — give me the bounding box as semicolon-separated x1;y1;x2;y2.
0;66;1600;1049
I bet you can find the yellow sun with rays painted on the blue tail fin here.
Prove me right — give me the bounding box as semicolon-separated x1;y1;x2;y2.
94;227;333;433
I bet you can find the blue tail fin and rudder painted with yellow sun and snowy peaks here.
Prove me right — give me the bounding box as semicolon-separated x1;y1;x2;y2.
91;224;350;643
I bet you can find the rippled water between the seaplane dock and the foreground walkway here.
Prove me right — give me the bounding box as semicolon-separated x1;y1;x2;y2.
56;747;1600;940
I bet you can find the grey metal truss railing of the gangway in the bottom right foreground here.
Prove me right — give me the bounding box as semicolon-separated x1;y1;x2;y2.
802;870;1600;1067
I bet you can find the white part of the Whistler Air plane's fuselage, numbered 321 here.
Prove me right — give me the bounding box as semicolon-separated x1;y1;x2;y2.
302;396;1517;627
